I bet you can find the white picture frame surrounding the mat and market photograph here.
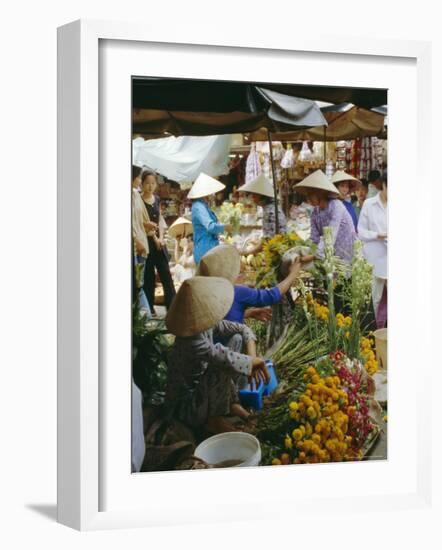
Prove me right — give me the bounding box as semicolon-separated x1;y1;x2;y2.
58;21;433;530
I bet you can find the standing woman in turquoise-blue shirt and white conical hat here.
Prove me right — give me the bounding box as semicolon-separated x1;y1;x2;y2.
187;173;232;264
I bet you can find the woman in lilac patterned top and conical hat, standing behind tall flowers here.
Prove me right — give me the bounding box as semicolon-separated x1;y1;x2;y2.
294;170;357;263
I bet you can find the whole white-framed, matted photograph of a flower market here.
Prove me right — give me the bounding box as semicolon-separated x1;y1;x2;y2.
58;21;432;530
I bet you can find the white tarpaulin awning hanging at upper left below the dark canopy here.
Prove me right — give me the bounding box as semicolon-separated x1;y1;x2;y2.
132;135;232;184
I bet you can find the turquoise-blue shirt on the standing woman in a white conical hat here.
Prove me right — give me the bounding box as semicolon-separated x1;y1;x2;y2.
192;199;224;264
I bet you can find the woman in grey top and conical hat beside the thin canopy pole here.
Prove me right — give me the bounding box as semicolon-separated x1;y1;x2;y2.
238;174;287;254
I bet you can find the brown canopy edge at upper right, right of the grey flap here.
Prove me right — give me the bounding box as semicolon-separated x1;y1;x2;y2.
249;105;386;141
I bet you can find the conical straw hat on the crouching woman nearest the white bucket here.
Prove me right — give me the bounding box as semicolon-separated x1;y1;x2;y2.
166;277;233;337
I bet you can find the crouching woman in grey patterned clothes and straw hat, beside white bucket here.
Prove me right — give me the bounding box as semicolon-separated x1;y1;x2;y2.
166;277;269;433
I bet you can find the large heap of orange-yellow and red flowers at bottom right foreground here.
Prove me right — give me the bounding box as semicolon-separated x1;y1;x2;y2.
272;351;375;465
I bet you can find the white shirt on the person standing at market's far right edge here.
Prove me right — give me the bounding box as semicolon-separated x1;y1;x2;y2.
358;193;388;279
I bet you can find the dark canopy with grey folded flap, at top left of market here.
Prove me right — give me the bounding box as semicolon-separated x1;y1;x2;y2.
133;79;327;137
